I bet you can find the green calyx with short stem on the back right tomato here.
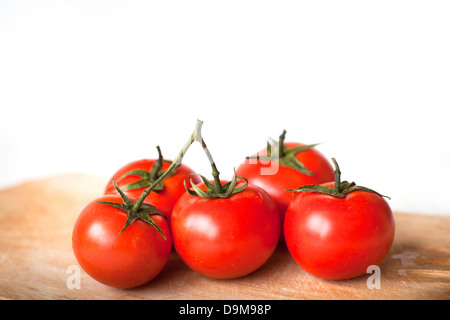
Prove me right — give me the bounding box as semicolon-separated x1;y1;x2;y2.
246;130;318;176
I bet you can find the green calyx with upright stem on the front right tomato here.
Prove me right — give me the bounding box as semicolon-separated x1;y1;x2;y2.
286;158;391;199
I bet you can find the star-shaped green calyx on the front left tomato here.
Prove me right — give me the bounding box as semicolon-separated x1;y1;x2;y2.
98;180;167;240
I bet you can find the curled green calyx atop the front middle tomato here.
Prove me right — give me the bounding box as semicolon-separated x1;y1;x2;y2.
184;170;248;199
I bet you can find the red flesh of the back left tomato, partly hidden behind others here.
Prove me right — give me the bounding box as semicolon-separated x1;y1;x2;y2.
105;159;201;221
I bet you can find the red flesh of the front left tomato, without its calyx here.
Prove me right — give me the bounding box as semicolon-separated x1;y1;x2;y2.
72;195;172;288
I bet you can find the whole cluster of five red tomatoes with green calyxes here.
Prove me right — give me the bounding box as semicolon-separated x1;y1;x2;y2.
72;121;394;288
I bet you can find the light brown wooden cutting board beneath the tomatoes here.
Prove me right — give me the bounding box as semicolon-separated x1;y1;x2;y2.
0;174;450;300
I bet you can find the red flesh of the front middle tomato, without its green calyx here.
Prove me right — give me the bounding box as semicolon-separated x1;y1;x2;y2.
171;184;280;279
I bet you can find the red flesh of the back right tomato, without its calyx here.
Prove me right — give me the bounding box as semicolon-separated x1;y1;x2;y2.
236;142;334;240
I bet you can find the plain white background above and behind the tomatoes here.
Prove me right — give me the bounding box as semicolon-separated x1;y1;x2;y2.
0;0;450;215
